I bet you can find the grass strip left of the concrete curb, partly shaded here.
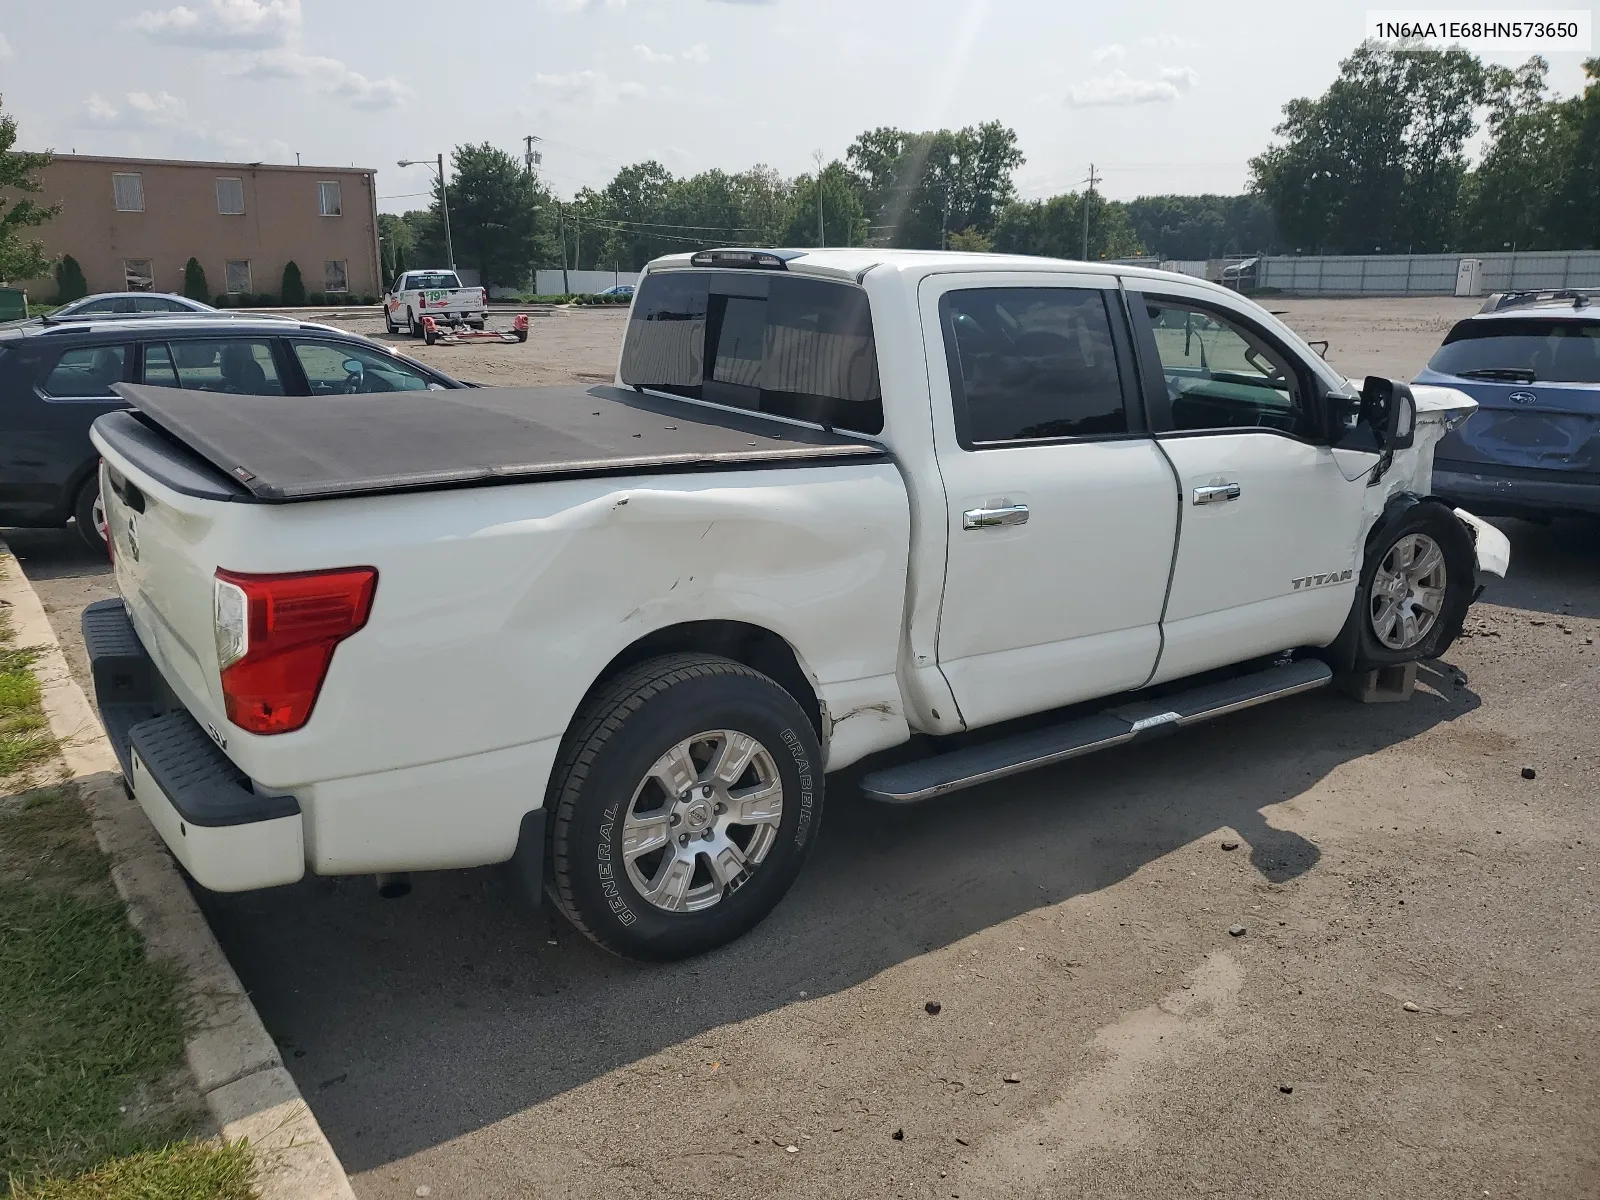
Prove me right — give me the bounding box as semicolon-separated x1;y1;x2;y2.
0;619;254;1200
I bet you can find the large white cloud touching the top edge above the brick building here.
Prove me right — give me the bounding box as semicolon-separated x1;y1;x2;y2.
133;0;410;110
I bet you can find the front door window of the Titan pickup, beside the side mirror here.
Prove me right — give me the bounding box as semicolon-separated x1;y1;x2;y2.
1144;296;1315;437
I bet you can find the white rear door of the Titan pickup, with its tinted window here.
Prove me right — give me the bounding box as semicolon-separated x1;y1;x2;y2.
920;272;1178;728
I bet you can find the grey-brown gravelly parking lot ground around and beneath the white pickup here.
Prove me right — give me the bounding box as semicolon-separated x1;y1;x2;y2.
6;299;1600;1200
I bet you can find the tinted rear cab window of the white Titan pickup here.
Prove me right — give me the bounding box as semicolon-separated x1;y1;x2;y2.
621;269;883;434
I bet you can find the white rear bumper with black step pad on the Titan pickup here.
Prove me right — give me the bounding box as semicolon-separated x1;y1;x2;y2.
83;600;306;891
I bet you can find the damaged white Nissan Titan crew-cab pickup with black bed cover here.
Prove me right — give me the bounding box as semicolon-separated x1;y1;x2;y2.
83;250;1509;958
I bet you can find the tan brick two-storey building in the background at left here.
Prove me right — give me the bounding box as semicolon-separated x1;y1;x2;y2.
11;154;382;301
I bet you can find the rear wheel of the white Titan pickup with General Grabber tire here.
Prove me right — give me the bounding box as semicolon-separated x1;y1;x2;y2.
546;654;822;960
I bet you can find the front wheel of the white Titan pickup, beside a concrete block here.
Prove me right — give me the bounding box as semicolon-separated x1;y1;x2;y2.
1350;501;1477;670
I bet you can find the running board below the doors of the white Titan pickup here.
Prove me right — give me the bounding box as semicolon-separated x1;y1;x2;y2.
861;659;1333;805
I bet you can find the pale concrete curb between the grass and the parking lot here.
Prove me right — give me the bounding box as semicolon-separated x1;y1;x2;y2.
0;542;355;1200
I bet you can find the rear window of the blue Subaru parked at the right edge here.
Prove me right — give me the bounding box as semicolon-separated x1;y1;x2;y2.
1427;317;1600;384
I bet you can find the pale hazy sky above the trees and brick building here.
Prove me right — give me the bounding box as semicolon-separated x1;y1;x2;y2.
0;0;1600;211
